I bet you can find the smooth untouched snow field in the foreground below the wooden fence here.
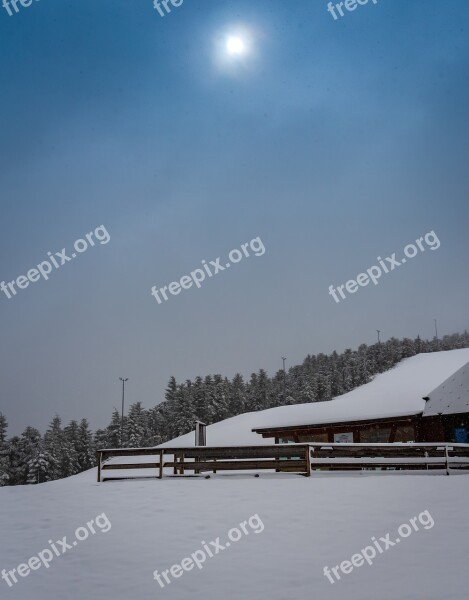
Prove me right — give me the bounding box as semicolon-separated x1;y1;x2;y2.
0;471;469;600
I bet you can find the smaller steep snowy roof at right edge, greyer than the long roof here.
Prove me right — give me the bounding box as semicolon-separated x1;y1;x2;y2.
423;364;469;417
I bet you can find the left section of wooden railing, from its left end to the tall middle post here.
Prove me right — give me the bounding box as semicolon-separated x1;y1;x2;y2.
97;444;310;481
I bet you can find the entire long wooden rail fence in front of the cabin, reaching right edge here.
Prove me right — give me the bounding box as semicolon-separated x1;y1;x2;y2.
97;442;469;482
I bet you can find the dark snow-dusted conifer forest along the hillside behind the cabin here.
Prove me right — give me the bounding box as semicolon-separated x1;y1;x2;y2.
0;331;469;486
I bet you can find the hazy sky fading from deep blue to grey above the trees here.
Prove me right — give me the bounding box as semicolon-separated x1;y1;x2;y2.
0;0;469;434
